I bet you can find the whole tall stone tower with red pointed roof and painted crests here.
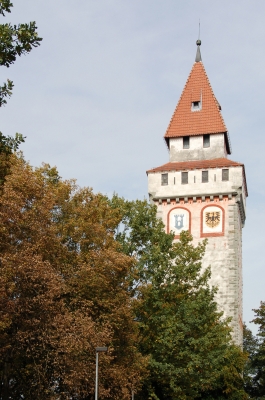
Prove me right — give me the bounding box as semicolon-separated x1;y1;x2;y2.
147;40;245;345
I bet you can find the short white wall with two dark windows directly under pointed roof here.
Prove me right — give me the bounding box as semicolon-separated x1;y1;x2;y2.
169;133;227;162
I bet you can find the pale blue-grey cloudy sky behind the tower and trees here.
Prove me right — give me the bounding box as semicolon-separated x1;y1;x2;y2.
0;0;265;331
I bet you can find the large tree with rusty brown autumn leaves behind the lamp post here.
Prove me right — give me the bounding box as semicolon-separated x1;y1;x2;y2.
0;155;145;400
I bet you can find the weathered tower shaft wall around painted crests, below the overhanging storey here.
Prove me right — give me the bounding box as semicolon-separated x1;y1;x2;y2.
156;196;242;345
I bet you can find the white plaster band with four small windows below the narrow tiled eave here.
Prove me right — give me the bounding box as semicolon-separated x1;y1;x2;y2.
148;166;245;201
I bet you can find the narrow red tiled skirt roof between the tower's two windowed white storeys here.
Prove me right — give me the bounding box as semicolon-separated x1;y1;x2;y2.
146;158;244;174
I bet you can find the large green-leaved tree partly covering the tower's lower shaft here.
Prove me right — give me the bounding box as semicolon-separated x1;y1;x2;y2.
113;196;247;400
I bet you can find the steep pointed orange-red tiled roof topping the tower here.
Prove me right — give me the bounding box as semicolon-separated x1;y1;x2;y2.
164;60;231;154
